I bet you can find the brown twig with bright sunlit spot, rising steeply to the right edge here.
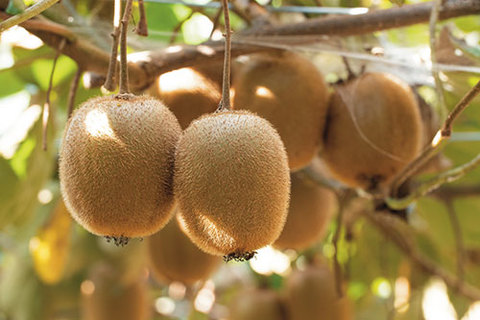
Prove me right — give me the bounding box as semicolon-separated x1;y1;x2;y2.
391;81;480;197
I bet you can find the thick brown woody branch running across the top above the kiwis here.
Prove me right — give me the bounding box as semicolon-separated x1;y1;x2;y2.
0;0;480;90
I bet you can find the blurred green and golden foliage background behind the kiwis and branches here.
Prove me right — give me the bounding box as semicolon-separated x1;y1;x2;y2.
0;0;480;320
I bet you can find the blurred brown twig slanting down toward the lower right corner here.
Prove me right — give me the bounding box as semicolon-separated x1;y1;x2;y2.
364;210;480;301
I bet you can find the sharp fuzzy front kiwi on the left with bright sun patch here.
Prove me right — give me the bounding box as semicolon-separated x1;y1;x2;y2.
59;96;181;237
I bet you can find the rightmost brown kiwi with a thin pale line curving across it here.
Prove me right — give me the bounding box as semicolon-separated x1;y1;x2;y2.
321;73;423;191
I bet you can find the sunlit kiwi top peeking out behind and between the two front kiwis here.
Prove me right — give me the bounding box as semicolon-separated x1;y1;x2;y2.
147;68;221;129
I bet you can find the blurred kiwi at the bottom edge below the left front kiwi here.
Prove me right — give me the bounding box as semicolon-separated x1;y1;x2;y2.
81;263;150;320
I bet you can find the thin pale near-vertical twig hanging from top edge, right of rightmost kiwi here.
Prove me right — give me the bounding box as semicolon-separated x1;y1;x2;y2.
429;0;448;120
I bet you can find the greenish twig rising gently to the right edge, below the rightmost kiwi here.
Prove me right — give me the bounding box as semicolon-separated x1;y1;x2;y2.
385;154;480;210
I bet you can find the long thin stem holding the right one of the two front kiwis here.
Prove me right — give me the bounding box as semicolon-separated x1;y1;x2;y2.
217;0;232;111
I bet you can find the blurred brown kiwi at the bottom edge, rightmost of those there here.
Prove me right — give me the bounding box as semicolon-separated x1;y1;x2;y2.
286;265;353;320
